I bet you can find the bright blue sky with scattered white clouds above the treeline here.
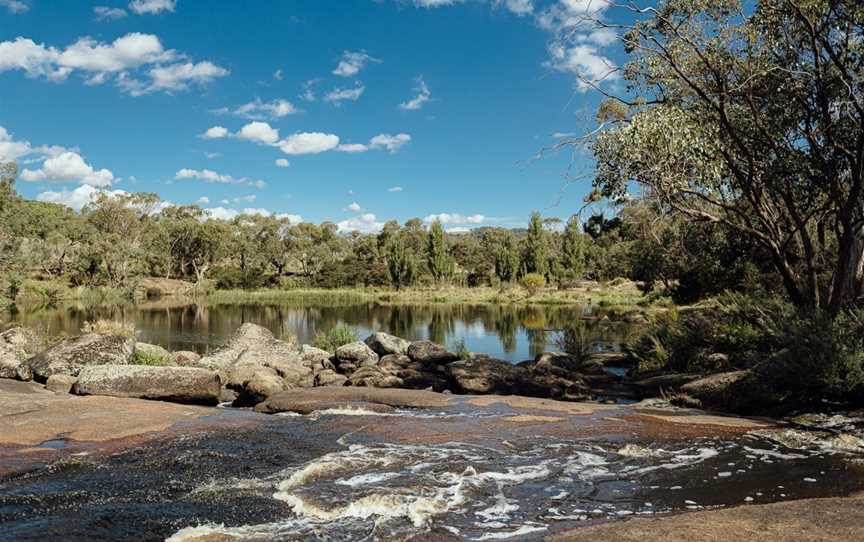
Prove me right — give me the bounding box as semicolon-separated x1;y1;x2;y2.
0;0;620;231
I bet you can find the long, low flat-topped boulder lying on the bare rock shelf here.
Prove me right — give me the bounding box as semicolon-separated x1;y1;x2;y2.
72;365;222;405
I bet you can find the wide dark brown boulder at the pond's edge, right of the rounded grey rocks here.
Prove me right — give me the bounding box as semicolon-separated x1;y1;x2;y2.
447;358;527;395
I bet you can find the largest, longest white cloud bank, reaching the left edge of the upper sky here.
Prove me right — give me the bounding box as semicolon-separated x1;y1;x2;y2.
0;32;229;96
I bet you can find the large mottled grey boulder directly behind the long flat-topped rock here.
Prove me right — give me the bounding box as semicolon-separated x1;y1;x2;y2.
26;333;135;382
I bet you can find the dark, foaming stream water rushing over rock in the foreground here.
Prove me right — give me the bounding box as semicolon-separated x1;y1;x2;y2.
0;404;864;542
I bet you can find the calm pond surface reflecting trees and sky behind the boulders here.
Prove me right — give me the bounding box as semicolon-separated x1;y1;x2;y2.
3;302;631;362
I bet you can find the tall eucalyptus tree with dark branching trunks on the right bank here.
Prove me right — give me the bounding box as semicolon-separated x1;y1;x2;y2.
571;0;864;318
